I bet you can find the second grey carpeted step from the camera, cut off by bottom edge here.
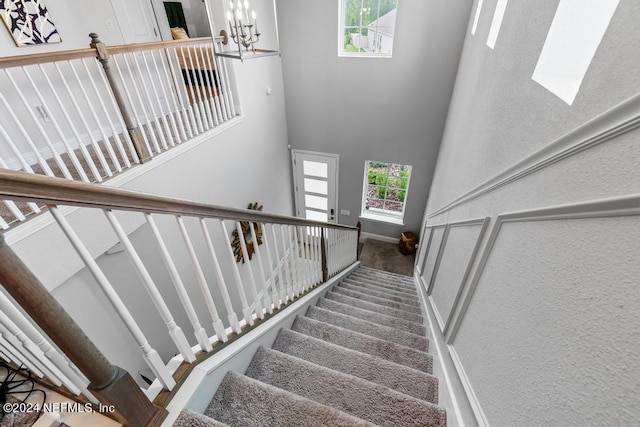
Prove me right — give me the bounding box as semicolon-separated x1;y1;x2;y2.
205;372;373;427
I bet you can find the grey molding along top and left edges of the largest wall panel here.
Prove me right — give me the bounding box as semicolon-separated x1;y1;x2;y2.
447;194;640;345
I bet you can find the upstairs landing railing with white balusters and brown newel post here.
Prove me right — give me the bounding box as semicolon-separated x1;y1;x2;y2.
0;34;237;230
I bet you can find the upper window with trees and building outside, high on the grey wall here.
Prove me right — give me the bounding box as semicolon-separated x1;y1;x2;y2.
339;0;398;56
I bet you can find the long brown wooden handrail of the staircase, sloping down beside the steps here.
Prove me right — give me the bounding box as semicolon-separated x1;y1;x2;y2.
0;168;357;230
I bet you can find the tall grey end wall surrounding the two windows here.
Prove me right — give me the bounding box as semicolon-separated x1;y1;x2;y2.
277;0;471;237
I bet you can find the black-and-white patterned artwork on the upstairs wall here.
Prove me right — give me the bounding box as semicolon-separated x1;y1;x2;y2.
0;0;62;46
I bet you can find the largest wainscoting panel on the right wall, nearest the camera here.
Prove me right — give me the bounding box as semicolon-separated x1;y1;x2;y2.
448;196;640;426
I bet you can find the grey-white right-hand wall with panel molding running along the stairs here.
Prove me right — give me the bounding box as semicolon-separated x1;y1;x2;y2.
417;0;640;426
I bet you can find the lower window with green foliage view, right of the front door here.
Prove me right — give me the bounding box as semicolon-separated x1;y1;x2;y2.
362;160;412;224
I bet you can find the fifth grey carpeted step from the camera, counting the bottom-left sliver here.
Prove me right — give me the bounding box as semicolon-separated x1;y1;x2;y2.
291;316;433;373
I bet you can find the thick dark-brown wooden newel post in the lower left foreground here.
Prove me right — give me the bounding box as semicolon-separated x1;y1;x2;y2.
0;234;167;427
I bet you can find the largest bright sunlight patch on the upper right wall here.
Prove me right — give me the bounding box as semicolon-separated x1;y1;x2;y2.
532;0;620;105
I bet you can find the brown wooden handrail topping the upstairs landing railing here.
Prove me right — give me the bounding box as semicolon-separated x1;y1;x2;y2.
0;36;223;69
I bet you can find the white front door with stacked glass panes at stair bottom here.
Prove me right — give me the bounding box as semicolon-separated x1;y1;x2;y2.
291;150;338;223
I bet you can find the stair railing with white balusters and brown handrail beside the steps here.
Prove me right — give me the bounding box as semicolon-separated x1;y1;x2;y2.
0;170;358;408
